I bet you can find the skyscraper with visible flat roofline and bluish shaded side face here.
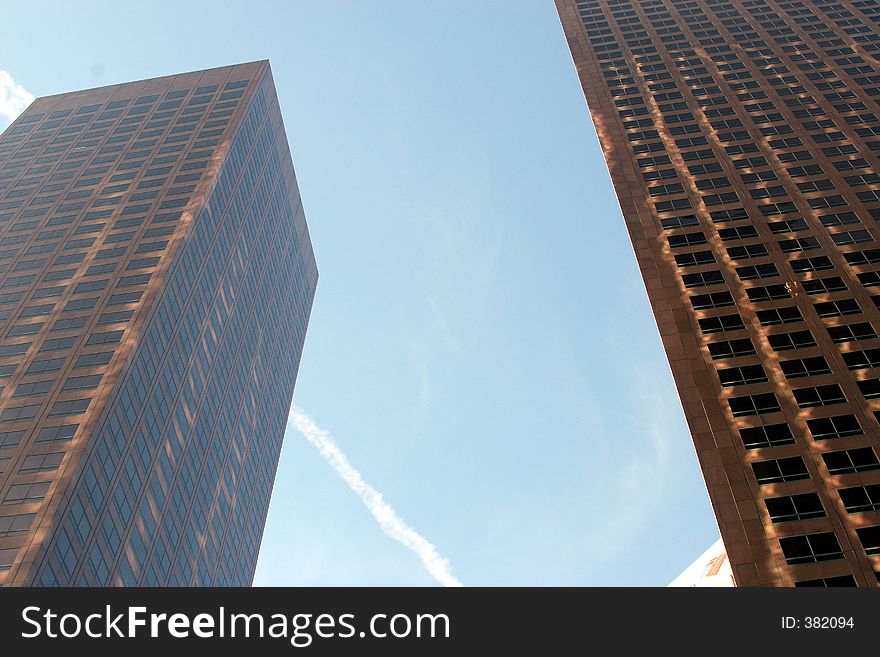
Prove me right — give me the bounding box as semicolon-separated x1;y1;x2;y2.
0;61;318;586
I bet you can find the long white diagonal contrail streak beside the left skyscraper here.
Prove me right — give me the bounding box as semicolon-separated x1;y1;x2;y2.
287;406;462;586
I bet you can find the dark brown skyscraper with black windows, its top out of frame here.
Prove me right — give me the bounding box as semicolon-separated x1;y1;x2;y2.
556;0;880;586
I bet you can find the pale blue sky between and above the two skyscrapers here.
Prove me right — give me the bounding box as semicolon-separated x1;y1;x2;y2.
0;0;718;586
